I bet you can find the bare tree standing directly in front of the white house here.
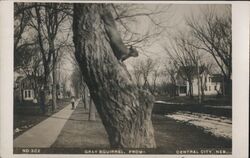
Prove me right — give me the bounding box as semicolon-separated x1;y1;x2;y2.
165;28;215;103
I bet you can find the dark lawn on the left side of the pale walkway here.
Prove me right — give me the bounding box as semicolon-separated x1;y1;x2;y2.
13;99;70;138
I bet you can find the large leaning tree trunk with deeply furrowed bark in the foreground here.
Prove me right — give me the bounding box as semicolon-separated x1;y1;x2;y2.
73;4;156;148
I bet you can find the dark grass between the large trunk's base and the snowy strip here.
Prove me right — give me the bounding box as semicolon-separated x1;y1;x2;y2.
152;115;232;153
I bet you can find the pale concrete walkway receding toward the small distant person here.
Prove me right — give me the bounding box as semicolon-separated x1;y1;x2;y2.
13;100;79;148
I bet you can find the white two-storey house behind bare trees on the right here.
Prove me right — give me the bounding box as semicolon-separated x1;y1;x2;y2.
176;65;223;96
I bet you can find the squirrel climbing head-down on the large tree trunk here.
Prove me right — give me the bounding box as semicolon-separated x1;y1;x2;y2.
101;10;139;61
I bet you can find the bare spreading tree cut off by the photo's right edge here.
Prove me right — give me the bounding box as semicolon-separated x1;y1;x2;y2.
186;7;232;94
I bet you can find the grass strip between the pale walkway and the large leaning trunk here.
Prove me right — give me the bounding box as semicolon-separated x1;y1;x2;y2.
51;102;109;148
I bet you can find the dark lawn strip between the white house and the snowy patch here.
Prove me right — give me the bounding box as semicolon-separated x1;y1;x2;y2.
153;96;232;118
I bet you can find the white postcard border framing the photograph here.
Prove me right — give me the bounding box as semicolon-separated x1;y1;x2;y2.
0;0;250;158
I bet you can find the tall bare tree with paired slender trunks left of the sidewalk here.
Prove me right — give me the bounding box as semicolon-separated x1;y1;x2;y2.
23;3;71;111
